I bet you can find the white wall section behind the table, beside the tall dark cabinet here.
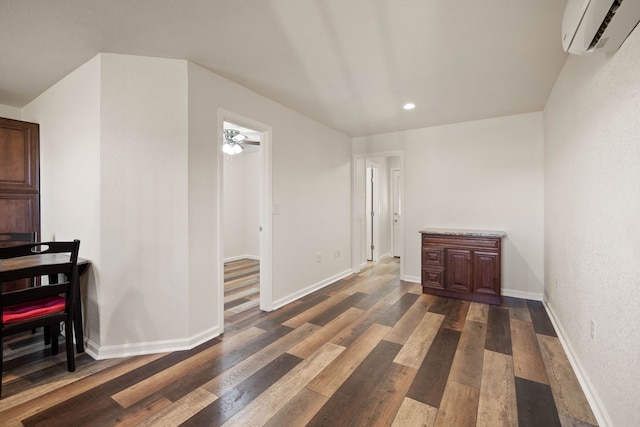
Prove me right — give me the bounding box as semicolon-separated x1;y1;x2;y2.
21;56;101;342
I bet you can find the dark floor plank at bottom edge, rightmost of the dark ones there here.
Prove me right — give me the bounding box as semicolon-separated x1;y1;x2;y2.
515;377;561;427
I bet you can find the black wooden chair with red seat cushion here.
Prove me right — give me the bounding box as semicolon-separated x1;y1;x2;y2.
0;240;80;395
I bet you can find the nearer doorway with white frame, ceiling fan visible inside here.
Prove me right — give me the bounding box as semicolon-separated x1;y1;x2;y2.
217;110;272;333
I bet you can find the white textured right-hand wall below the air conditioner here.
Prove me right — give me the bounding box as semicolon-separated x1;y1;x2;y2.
544;29;640;426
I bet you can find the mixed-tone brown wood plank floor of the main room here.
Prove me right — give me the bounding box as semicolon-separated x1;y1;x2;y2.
0;259;596;427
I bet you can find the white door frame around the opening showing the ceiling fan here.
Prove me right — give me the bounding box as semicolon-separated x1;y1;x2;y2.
216;108;273;333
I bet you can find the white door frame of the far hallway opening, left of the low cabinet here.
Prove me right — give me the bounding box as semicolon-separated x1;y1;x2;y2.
351;150;406;279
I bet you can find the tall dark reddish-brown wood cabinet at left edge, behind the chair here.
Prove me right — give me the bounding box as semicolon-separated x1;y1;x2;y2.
0;118;40;236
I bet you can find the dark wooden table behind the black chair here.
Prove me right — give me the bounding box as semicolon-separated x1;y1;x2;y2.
0;253;91;353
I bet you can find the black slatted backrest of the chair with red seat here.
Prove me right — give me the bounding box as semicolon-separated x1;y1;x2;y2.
0;240;80;316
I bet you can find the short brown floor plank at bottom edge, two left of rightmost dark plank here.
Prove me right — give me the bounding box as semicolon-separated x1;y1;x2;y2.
434;381;480;427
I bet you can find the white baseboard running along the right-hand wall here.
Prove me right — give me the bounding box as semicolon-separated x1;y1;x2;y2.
542;301;613;427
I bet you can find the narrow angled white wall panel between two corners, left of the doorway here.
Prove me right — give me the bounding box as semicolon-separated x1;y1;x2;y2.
100;54;189;352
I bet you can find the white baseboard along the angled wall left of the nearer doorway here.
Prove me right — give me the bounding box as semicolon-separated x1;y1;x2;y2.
85;326;220;360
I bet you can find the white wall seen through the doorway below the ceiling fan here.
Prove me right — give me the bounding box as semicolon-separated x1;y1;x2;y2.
223;151;262;260
